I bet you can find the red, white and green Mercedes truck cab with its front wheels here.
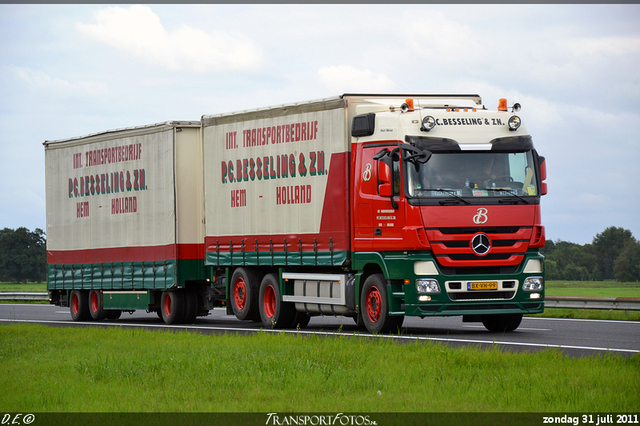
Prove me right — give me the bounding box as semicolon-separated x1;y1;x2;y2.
351;96;547;331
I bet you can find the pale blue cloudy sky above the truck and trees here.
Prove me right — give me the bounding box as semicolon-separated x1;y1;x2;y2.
0;4;640;244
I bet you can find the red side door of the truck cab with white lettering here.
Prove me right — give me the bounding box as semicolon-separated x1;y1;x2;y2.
354;144;405;251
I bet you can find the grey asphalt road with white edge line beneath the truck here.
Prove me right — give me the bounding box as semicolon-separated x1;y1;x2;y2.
0;304;640;357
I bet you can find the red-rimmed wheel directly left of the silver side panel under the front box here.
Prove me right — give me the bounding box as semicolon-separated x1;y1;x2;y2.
258;274;296;328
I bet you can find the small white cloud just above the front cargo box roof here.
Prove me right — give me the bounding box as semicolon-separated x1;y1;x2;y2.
318;65;396;93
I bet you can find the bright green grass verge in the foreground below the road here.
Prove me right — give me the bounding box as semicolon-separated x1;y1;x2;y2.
0;324;640;413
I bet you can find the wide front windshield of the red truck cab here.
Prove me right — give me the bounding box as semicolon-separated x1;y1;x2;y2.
406;151;539;199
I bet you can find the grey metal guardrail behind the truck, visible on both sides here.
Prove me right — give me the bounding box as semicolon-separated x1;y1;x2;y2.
0;291;640;311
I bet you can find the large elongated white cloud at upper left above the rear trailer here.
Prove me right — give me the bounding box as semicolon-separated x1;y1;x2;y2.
76;5;262;72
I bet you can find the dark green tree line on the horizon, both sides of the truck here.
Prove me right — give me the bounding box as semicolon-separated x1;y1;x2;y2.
0;226;640;283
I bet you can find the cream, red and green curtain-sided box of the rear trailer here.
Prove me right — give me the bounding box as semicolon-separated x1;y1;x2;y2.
44;122;203;288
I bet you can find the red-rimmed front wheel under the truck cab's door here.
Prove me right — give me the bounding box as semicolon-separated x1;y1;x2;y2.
360;274;404;333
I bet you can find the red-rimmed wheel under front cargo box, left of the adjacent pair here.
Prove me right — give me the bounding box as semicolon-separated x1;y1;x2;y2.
230;268;262;321
